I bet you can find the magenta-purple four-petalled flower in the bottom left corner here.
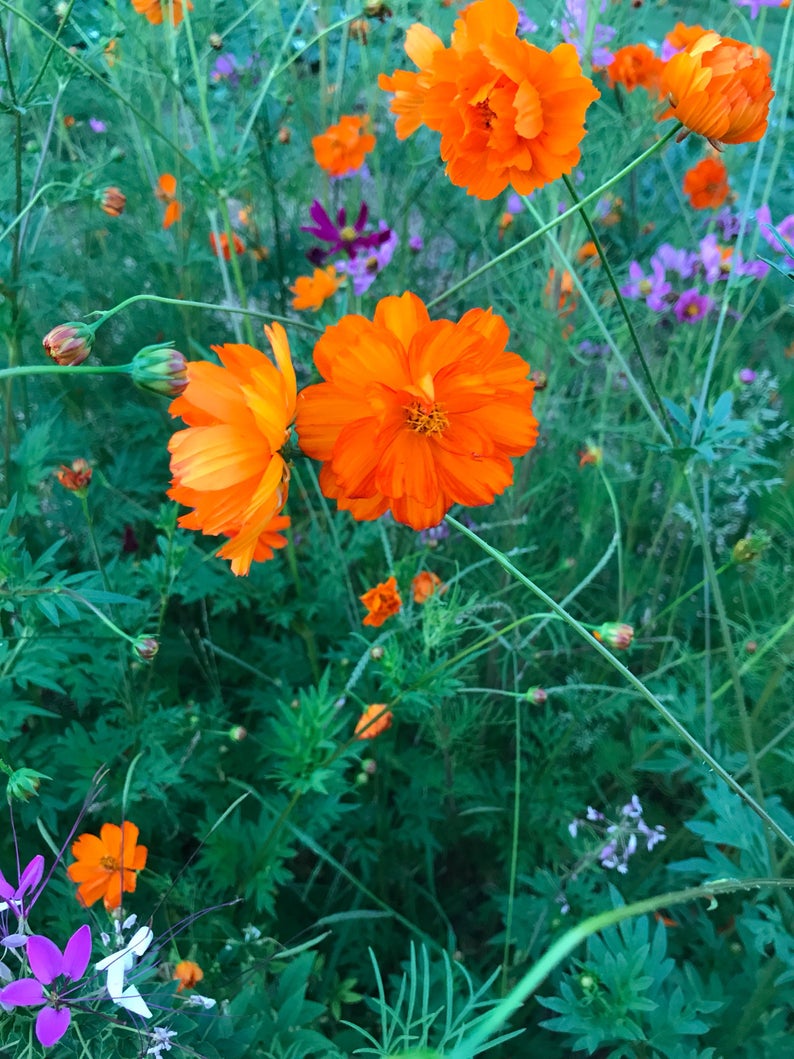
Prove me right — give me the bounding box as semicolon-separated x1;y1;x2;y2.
0;923;91;1048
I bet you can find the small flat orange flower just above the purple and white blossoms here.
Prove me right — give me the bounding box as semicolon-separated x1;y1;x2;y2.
67;820;148;910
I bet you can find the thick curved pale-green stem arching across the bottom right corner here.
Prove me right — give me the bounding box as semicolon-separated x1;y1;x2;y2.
449;879;794;1059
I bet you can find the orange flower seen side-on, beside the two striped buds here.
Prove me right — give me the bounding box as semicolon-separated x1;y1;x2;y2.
168;323;295;574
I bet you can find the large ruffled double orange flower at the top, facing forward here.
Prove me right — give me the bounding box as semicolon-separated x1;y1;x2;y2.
378;0;600;199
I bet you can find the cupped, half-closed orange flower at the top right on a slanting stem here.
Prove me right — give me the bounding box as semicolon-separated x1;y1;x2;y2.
662;33;775;146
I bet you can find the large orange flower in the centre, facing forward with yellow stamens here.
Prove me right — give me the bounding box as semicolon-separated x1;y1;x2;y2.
297;292;538;530
